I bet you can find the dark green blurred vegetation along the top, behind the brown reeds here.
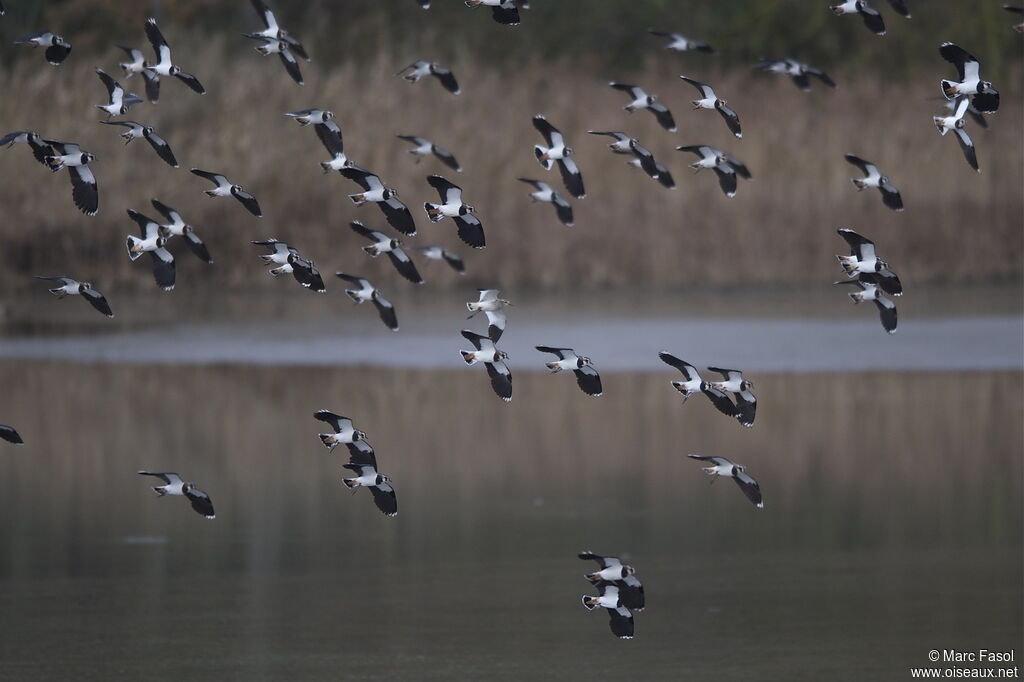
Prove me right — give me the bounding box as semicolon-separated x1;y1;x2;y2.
0;0;1021;80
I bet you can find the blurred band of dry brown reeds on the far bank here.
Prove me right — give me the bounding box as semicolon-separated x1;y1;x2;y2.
0;45;1024;291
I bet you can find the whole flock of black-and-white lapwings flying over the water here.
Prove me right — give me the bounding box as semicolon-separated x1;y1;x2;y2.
0;0;1024;638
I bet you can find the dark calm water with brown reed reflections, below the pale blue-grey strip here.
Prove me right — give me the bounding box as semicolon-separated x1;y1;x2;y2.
0;358;1024;681
